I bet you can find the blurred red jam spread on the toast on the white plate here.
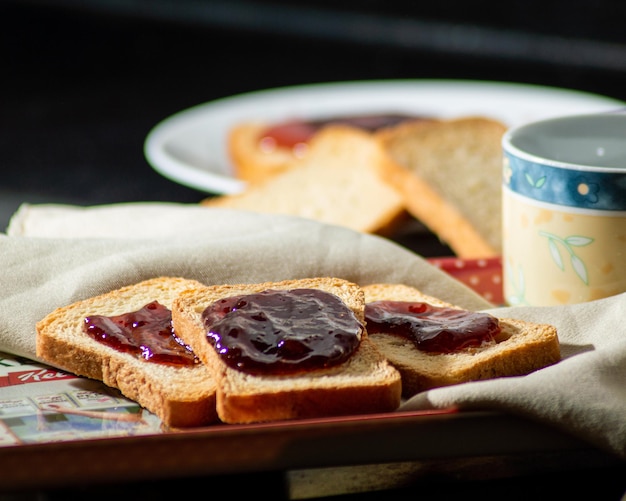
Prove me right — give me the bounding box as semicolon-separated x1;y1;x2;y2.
259;114;422;151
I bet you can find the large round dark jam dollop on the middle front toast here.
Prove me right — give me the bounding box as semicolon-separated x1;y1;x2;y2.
202;289;363;374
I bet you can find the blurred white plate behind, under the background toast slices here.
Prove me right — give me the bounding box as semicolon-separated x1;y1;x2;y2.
144;80;625;194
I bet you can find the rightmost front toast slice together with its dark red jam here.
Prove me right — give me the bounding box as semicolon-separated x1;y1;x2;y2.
363;284;561;398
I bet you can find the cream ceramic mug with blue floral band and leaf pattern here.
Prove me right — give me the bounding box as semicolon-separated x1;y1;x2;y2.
502;113;626;306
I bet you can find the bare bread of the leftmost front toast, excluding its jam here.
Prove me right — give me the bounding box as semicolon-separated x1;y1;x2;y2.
37;277;217;427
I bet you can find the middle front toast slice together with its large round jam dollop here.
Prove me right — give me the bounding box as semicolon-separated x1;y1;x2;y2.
172;277;401;423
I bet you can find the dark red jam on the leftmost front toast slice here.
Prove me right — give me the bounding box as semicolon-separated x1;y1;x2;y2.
83;301;200;365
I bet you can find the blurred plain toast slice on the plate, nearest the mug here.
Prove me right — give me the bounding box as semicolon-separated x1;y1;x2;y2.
376;117;506;258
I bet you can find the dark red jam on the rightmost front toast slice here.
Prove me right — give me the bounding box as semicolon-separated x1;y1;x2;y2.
365;301;501;353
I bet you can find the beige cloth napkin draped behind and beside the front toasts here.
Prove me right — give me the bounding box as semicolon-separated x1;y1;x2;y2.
0;203;626;459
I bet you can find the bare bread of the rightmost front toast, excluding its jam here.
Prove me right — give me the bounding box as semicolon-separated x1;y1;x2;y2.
363;284;561;397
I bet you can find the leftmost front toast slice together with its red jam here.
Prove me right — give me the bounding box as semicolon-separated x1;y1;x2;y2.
36;277;218;427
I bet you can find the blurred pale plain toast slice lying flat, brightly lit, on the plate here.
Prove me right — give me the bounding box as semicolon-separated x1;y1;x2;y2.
201;126;406;234
